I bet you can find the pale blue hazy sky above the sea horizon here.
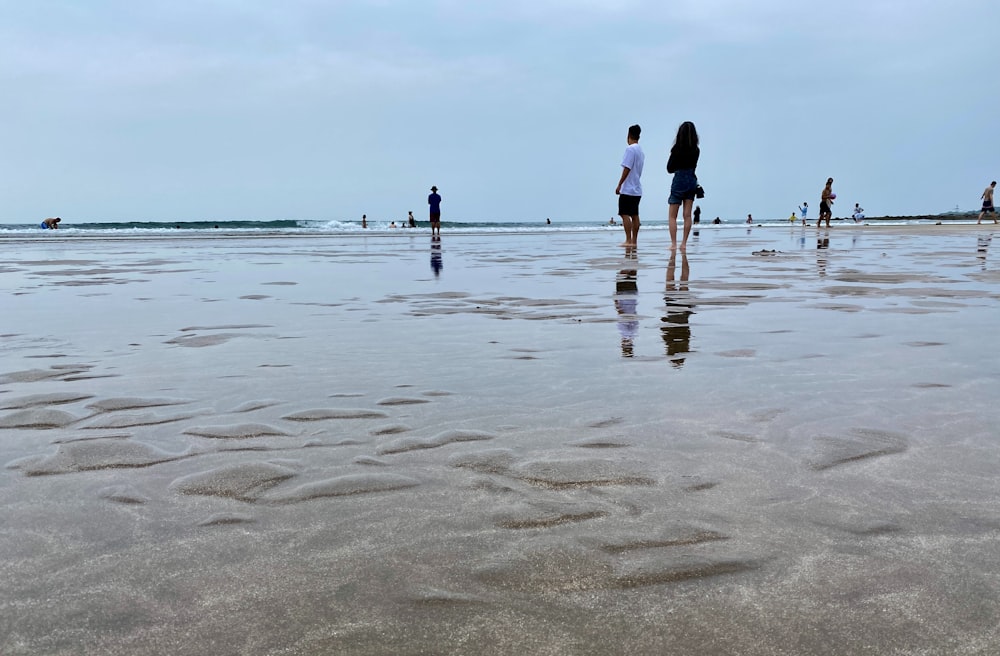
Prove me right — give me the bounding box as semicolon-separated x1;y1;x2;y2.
0;0;1000;224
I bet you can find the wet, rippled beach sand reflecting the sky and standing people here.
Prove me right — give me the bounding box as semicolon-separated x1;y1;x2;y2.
0;226;1000;655
